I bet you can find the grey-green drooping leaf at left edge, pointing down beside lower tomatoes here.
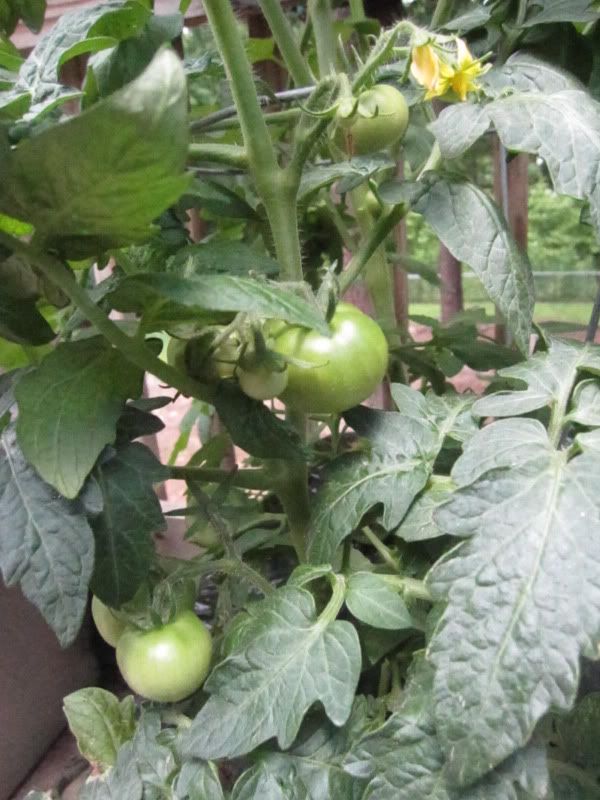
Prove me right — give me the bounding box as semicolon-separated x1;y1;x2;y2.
0;424;94;646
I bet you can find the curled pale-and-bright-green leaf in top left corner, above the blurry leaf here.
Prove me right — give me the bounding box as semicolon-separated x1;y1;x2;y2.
0;0;150;119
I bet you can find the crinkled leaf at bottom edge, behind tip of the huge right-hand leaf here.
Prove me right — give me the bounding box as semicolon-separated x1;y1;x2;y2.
345;660;548;800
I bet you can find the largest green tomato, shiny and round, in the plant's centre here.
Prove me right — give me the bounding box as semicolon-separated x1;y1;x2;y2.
270;303;388;414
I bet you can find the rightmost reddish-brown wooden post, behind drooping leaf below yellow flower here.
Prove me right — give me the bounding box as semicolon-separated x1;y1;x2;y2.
493;136;529;342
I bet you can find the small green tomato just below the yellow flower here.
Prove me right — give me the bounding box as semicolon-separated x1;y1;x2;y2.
335;83;408;155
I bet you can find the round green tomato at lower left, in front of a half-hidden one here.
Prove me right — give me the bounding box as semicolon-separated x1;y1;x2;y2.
117;611;212;703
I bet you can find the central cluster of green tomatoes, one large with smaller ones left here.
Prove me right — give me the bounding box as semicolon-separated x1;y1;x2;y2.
166;303;388;414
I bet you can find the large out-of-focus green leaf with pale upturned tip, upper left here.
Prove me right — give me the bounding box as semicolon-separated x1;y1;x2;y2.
0;50;188;258
